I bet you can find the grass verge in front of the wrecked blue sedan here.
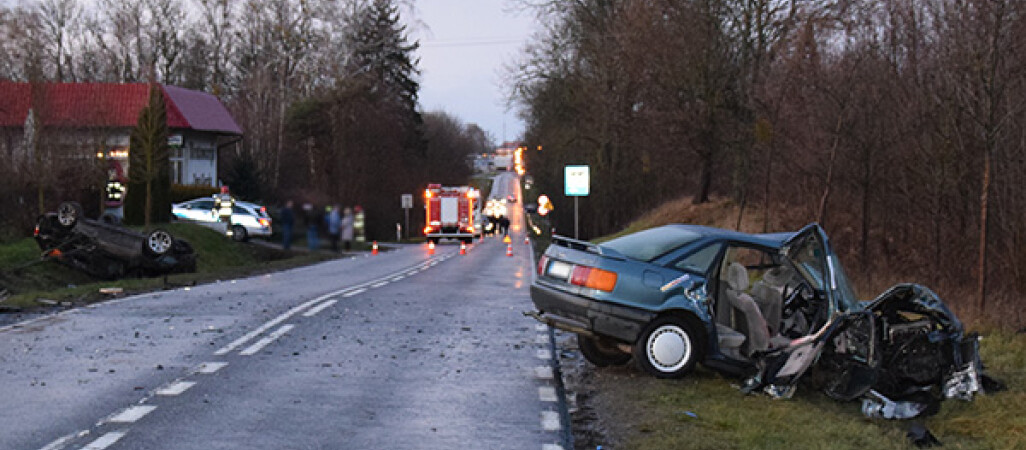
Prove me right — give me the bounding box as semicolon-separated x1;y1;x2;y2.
599;332;1026;450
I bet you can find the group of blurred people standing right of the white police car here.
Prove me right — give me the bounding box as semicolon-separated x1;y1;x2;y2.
278;200;355;251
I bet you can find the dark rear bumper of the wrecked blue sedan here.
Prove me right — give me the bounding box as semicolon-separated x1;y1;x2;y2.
530;281;656;342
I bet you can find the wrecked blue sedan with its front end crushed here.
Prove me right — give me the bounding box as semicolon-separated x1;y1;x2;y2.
529;223;996;414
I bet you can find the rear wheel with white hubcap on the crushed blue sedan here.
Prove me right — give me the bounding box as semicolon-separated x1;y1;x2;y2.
634;316;702;378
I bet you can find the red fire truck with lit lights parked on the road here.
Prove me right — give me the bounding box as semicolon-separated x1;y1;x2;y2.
424;185;481;244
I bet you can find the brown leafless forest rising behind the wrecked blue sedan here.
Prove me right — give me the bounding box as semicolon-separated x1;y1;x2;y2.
511;0;1026;326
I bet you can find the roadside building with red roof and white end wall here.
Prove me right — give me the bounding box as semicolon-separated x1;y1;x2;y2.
0;81;242;200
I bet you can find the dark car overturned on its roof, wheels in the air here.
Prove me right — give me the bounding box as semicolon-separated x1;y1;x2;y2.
33;202;196;279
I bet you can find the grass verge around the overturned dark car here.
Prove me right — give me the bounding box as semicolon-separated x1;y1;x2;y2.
0;223;333;309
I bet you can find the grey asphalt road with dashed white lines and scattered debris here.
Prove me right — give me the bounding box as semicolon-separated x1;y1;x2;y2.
0;176;565;450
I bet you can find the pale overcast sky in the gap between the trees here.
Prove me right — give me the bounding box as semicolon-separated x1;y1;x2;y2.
410;0;536;142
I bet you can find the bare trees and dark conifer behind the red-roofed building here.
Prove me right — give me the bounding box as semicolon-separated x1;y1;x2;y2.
0;0;492;237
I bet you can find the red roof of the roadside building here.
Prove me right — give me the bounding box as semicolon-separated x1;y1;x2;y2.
0;81;242;134
